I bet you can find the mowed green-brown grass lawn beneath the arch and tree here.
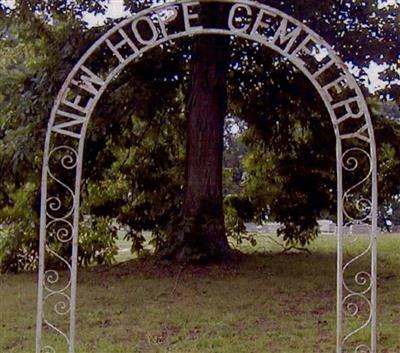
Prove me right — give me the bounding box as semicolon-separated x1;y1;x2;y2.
0;235;400;353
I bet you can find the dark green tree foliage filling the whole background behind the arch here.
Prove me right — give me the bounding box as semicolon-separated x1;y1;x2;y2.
0;0;400;270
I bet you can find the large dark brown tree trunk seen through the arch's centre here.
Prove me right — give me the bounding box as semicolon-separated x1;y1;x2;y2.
173;8;230;260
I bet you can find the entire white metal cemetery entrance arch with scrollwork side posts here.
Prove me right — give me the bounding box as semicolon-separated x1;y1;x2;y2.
36;0;377;353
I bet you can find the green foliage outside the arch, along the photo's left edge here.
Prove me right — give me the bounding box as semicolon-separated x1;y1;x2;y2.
0;1;104;271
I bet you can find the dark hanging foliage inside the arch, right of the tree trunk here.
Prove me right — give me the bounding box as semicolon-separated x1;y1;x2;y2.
231;48;336;245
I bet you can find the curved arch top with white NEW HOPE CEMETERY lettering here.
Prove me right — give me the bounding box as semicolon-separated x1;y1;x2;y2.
49;0;374;146
